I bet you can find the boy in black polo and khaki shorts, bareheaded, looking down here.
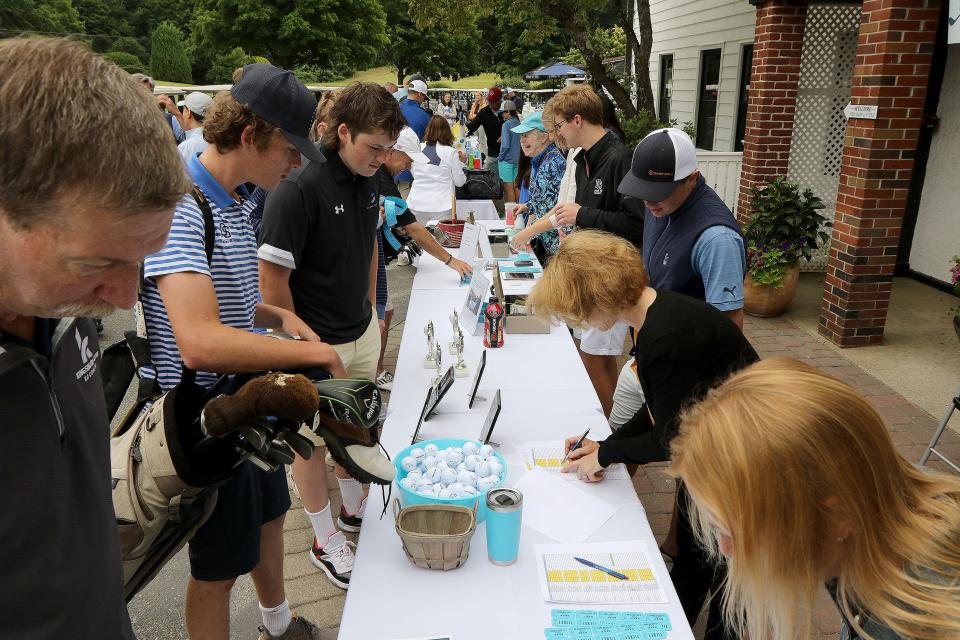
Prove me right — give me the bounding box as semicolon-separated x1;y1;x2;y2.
257;83;404;587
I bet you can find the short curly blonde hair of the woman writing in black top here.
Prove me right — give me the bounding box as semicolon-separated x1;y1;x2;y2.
527;230;649;326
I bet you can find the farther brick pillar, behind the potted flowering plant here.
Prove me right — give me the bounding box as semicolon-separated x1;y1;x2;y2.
737;0;807;222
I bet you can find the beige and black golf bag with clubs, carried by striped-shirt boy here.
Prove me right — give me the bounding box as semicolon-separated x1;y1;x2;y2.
120;372;380;602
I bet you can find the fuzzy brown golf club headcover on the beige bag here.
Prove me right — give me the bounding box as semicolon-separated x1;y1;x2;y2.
200;373;320;437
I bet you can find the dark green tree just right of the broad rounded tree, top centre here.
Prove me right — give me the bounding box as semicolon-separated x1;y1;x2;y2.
381;0;482;86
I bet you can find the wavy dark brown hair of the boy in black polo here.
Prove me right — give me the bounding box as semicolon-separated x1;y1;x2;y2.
323;82;406;151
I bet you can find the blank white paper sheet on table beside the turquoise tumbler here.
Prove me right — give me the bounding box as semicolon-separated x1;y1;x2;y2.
517;469;618;542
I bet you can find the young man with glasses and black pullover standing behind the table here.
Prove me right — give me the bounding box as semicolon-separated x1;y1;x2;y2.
549;85;643;416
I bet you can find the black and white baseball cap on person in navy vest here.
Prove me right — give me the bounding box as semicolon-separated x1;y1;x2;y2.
617;128;697;202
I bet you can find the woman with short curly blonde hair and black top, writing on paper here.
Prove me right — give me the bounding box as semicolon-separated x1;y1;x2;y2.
527;229;757;640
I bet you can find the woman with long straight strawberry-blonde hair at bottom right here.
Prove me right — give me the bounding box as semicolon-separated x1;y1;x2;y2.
672;358;960;640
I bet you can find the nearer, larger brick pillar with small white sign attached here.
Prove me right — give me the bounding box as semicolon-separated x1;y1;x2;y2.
819;0;940;347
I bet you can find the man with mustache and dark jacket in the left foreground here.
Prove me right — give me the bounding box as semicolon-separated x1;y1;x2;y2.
0;38;190;640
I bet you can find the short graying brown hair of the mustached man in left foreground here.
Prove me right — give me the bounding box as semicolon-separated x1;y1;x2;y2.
0;38;190;228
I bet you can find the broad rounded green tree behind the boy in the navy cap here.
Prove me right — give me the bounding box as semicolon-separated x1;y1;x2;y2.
191;0;386;75
